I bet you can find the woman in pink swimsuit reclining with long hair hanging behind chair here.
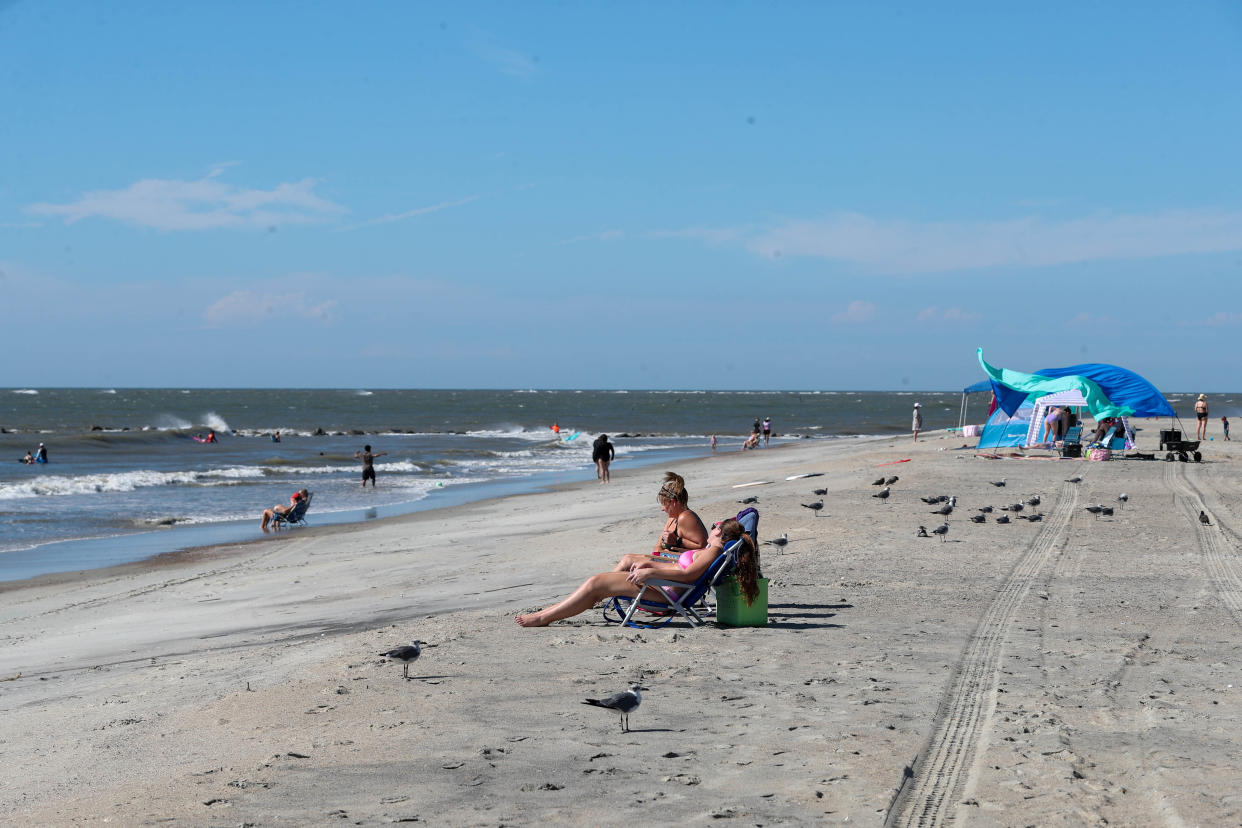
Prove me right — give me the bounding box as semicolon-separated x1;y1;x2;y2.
514;519;759;627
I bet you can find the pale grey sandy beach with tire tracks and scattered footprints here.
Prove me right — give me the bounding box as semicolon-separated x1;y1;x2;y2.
0;423;1242;826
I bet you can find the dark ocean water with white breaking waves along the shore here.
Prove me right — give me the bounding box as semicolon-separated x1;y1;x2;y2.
0;389;1227;581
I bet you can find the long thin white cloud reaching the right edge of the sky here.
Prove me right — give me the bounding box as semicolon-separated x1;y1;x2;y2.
748;210;1242;273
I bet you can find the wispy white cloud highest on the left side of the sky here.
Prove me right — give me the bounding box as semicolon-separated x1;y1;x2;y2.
26;165;345;230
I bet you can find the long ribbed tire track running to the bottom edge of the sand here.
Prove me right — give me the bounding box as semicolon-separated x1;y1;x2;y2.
884;483;1078;828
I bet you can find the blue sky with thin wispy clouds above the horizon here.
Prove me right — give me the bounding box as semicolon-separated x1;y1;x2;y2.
0;0;1242;391
